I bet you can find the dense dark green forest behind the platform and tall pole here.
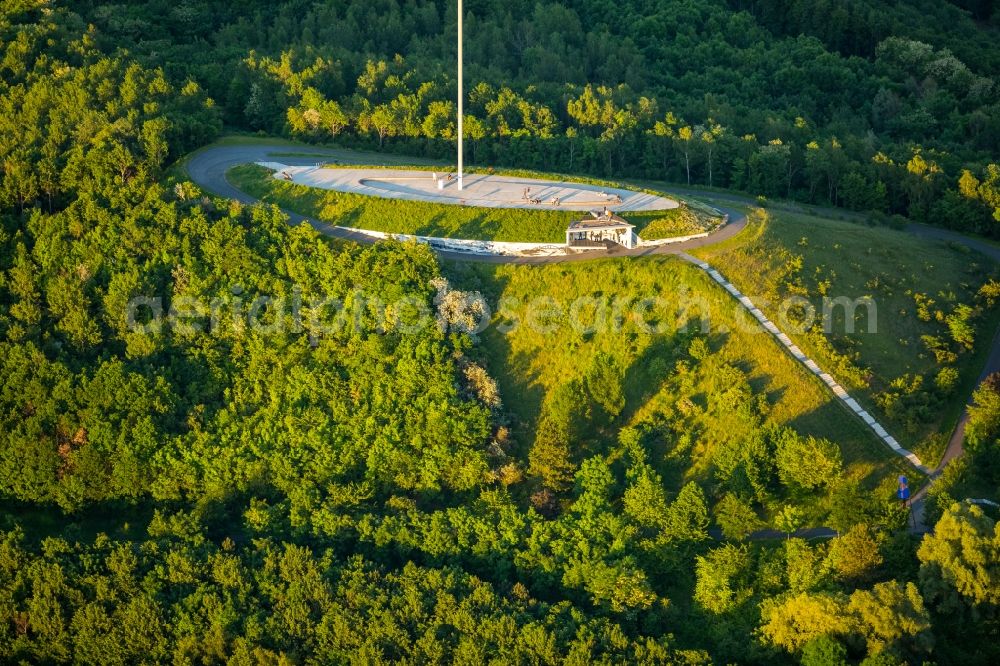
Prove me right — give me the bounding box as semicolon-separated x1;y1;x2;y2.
60;0;1000;234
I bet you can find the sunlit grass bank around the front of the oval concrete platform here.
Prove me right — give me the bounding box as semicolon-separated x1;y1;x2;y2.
227;164;715;243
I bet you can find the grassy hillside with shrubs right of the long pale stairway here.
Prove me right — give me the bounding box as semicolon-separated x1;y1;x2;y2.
695;211;1000;467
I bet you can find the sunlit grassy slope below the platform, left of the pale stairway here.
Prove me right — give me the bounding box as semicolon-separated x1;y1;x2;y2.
445;257;912;524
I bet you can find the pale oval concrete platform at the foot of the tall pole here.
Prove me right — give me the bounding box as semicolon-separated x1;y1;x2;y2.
258;162;680;213
